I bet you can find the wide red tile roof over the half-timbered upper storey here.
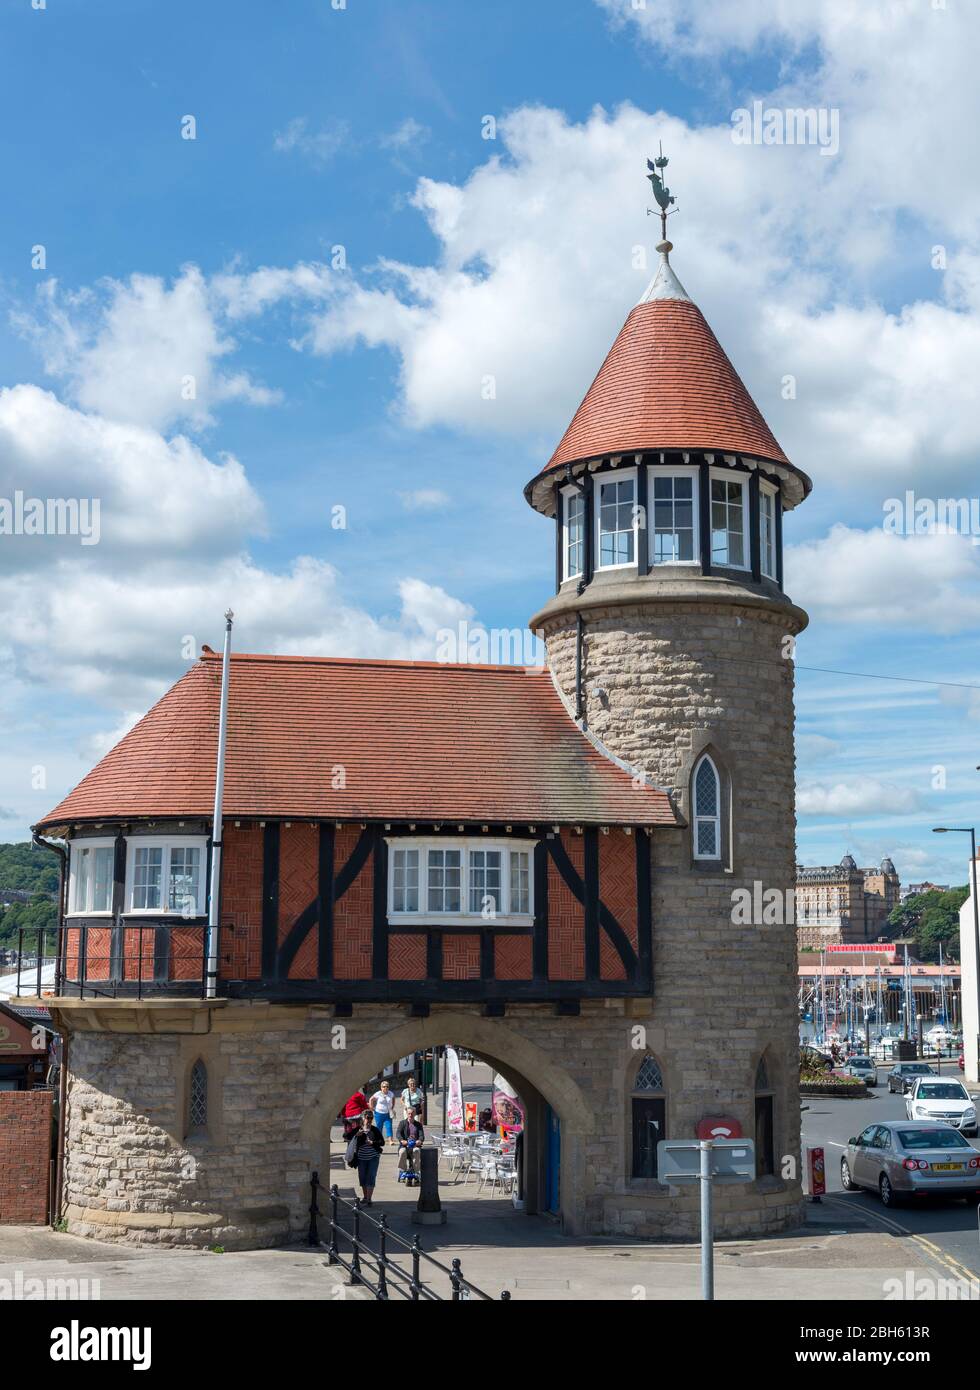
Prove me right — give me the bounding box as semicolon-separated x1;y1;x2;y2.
40;652;676;826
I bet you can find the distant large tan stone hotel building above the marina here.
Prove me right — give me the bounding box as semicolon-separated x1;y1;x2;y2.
797;855;901;951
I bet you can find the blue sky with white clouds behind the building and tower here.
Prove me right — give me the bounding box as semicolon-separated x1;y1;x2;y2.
0;0;980;883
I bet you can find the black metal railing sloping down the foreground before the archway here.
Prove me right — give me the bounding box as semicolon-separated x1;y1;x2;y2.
309;1173;510;1302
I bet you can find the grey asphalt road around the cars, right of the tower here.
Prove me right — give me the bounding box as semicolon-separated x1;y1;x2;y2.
803;1068;980;1277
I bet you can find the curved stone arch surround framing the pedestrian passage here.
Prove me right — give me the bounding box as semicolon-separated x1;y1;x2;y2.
300;1012;595;1234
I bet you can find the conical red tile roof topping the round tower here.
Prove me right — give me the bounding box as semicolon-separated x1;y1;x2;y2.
545;299;788;473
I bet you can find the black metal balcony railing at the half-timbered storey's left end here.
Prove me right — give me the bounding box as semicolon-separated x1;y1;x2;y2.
15;916;222;999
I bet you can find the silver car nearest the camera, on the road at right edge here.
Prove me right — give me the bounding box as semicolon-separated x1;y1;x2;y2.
841;1120;980;1207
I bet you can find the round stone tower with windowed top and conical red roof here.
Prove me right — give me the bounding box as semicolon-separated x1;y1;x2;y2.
525;240;810;1232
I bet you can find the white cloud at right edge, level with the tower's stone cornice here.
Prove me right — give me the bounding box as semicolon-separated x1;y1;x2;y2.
785;525;980;634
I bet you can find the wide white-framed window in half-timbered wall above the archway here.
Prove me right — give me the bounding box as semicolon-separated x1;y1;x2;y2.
388;837;534;926
